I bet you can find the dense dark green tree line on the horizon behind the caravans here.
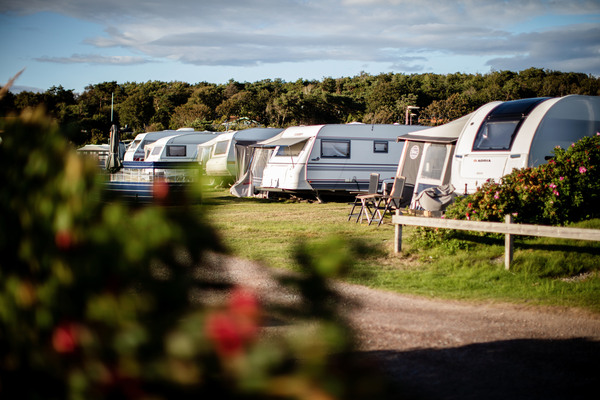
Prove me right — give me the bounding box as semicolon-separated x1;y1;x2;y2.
0;68;600;145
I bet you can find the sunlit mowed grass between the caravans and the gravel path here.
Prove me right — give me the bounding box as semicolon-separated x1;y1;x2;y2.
204;190;600;313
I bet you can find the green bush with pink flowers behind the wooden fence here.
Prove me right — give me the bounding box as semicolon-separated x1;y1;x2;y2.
446;134;600;225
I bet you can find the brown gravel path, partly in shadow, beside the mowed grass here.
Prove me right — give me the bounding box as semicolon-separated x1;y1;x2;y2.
211;257;600;400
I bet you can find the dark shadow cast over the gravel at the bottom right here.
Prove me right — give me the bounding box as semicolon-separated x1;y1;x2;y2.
361;338;600;400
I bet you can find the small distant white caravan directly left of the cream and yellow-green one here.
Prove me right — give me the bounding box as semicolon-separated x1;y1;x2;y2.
144;131;216;162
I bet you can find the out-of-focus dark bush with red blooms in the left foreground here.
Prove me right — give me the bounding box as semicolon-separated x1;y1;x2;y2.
0;111;394;399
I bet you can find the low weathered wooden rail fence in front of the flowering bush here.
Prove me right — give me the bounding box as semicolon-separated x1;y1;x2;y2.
392;214;600;269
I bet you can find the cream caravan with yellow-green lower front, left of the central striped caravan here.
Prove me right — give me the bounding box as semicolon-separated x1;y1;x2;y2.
198;128;282;177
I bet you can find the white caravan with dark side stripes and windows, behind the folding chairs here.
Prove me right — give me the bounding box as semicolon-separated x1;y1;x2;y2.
258;124;425;197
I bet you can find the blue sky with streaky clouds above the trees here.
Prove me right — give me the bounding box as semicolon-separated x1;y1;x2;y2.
0;0;600;93
